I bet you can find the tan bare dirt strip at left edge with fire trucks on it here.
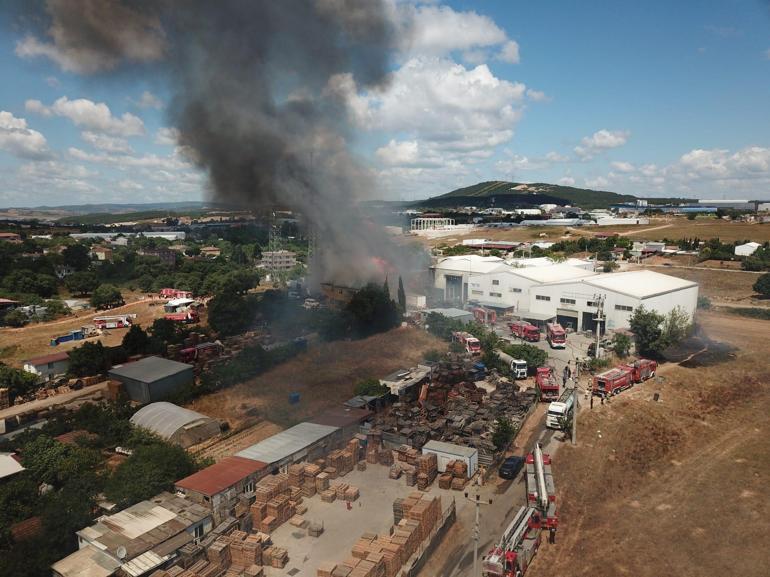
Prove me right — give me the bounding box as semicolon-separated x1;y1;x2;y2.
0;294;163;368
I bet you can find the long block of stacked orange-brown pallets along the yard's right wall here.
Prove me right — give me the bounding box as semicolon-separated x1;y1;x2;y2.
316;492;441;577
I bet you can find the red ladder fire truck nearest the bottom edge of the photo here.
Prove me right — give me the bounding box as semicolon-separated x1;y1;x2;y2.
481;507;542;577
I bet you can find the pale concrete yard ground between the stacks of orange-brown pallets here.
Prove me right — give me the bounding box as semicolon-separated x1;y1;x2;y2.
265;464;464;577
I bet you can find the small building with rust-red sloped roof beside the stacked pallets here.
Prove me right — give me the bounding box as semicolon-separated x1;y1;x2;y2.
175;457;268;526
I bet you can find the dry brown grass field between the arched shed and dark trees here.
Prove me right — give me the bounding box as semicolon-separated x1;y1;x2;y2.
188;328;447;429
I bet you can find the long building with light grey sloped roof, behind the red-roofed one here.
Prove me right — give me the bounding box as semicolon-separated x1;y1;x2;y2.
235;423;341;472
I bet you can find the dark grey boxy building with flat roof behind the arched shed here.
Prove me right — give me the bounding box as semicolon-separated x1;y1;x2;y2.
108;357;195;403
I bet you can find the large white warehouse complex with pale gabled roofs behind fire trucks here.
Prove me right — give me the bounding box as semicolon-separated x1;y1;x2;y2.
432;255;698;330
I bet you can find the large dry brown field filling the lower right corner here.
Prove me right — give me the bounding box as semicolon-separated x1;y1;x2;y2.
528;313;770;577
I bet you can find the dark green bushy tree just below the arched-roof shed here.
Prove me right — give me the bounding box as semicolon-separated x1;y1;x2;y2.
105;441;197;508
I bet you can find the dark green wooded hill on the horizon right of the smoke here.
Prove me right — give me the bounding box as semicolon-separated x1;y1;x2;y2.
414;180;679;209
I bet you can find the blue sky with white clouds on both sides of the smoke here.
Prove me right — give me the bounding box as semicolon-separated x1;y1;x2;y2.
0;0;770;206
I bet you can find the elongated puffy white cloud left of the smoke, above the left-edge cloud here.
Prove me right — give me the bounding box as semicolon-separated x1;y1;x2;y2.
25;96;144;136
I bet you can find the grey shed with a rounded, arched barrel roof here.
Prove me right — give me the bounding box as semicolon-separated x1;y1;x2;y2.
131;402;220;449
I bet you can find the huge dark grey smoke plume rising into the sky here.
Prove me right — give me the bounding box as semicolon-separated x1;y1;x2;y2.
16;0;424;283
